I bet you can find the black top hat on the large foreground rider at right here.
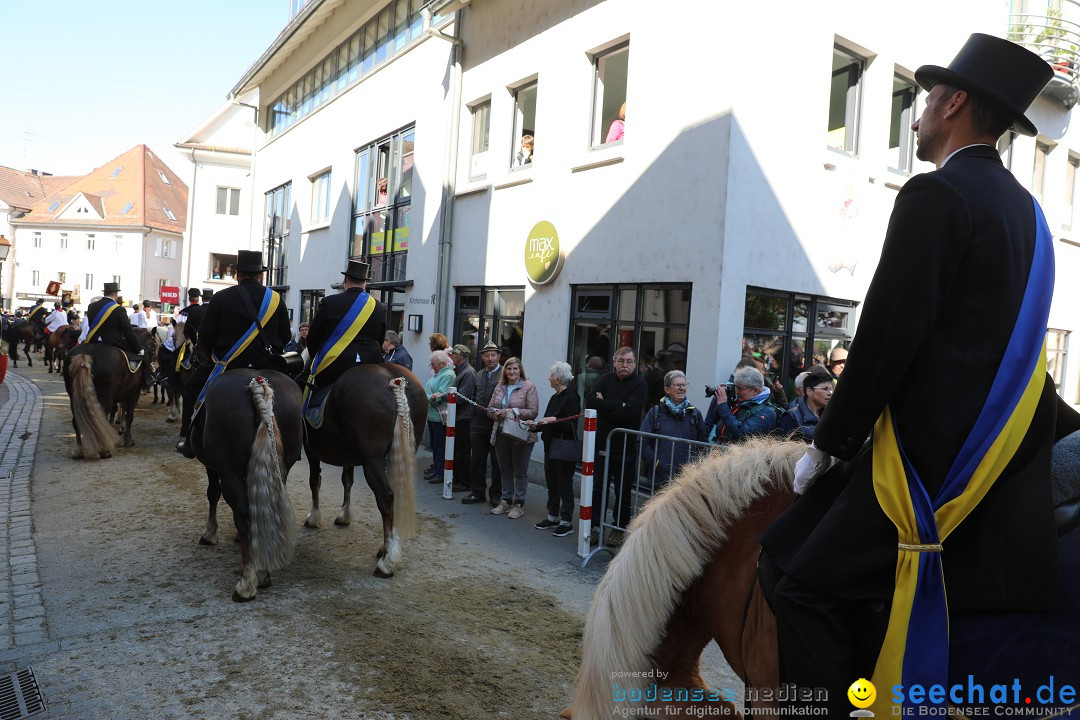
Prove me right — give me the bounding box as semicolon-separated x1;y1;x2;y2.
915;32;1054;135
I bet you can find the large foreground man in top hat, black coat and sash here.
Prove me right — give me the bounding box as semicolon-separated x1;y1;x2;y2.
759;35;1080;717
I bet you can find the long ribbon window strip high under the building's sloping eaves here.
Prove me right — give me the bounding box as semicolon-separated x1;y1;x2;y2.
266;0;432;136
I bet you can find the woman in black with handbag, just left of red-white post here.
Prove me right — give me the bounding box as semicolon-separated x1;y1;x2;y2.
534;363;581;538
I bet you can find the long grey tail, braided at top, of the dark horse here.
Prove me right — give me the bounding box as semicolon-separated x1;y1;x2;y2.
246;377;296;571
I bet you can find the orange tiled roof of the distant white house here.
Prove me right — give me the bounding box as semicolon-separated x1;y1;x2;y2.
16;145;188;233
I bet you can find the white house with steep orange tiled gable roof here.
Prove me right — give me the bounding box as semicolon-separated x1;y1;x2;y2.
12;145;188;308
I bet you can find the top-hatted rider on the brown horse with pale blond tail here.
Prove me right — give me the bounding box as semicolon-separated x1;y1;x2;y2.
308;260;387;395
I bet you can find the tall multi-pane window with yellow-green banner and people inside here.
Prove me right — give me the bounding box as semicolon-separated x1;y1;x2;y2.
349;127;416;288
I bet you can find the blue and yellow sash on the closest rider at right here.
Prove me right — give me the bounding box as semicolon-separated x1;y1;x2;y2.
873;199;1054;717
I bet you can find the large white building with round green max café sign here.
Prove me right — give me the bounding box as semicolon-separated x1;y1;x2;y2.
214;0;1080;404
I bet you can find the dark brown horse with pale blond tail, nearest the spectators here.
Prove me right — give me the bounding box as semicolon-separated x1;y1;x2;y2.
303;364;428;578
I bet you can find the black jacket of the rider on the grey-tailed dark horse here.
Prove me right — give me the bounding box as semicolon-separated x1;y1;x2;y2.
199;277;292;369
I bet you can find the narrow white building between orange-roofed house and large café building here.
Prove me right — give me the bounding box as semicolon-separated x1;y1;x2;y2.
175;94;261;302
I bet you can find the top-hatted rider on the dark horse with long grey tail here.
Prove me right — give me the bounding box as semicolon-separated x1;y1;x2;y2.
176;250;292;458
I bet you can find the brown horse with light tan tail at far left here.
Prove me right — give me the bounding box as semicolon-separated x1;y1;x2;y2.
64;342;143;459
